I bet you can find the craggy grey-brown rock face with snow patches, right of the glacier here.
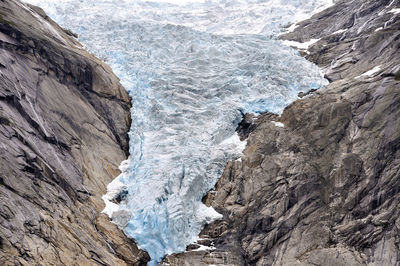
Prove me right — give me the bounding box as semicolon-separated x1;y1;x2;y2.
162;0;400;266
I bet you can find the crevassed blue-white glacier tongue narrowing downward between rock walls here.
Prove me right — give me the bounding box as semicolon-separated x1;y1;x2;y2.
23;0;331;264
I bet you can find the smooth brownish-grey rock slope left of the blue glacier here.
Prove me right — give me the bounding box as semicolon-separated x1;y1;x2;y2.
0;0;149;265
